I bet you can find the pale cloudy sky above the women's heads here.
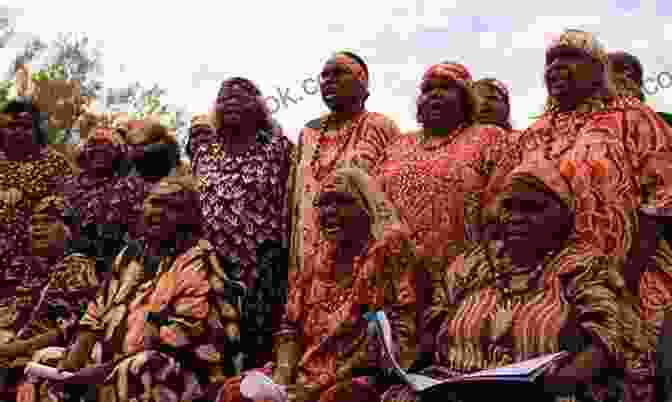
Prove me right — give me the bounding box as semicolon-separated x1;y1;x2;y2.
0;0;672;140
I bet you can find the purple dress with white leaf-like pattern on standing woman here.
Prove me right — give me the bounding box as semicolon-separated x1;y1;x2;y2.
193;133;291;288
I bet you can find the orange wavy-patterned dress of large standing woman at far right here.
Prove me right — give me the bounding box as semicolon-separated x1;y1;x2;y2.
484;99;672;258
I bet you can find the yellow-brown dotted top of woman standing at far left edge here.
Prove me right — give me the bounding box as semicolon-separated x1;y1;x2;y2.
0;148;72;266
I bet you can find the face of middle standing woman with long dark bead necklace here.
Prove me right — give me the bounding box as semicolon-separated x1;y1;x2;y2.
320;59;363;110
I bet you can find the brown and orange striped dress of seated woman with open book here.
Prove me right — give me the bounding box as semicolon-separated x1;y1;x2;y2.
383;241;639;402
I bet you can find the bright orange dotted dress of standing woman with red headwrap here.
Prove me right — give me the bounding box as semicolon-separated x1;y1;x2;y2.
378;125;507;256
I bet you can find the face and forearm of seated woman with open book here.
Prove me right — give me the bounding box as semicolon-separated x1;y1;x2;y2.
501;191;609;394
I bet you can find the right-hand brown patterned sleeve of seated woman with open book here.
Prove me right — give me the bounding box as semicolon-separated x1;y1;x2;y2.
559;256;639;367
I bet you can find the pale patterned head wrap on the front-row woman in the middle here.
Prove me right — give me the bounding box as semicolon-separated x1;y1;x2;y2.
317;166;399;240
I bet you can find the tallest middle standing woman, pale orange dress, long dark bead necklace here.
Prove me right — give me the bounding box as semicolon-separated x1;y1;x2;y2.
289;52;399;288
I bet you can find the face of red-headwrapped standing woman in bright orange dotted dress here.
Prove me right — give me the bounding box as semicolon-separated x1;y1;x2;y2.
418;79;467;137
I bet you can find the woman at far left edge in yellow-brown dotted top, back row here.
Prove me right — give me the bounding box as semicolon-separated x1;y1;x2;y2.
0;98;72;267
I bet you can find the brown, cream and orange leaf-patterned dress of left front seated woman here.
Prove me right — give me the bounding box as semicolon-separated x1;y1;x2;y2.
20;240;240;402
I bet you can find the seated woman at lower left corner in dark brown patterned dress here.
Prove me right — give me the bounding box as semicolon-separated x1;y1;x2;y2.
0;196;98;400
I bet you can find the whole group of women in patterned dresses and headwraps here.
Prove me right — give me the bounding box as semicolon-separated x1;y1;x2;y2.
0;29;672;402
